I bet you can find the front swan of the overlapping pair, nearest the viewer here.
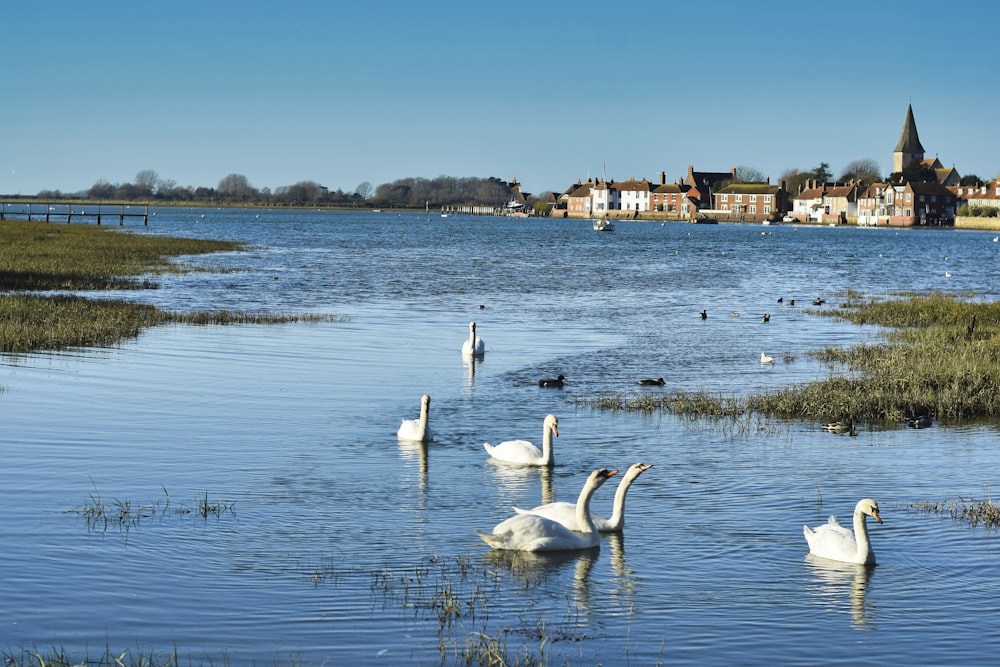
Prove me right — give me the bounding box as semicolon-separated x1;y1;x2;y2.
476;469;618;551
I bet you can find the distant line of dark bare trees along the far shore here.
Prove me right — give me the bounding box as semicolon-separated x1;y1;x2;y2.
27;169;528;208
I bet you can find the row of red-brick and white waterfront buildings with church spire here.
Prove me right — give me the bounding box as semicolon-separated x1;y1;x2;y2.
549;107;1000;226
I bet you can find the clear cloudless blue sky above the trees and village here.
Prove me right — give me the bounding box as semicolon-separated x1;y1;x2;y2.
0;0;1000;194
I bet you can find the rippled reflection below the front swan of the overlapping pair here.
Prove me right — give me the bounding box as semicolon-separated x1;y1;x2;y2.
483;547;601;612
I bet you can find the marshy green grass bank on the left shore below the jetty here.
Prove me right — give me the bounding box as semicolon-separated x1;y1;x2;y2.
0;220;336;353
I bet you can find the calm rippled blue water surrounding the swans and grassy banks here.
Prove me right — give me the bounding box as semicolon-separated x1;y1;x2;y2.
0;210;1000;665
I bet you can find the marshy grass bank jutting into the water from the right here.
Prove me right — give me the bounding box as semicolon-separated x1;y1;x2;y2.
583;294;1000;425
